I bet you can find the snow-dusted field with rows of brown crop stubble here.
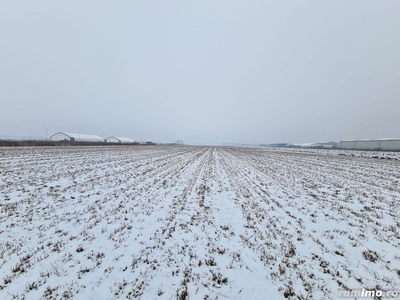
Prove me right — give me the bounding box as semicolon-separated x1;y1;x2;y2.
0;146;400;300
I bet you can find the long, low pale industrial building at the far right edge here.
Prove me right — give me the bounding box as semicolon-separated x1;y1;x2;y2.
339;139;400;151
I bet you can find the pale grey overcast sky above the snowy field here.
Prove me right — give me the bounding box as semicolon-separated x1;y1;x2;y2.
0;0;400;143
